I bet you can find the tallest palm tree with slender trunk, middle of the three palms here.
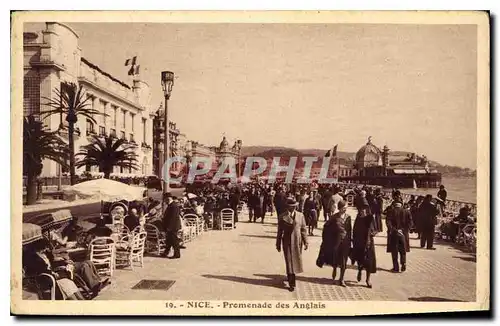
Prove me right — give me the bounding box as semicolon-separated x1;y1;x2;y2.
43;82;107;185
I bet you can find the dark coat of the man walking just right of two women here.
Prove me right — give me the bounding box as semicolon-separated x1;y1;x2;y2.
387;207;412;252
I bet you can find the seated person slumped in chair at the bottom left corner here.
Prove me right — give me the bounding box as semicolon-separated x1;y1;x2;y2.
23;239;85;300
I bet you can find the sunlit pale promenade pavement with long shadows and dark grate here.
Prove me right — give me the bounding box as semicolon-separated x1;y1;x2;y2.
96;211;476;301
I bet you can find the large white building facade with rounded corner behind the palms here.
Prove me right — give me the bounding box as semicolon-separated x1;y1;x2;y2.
23;23;154;177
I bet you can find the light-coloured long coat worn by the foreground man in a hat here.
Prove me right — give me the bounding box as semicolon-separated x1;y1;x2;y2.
276;211;307;274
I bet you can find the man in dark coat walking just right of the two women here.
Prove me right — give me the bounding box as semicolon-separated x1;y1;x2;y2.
387;202;412;273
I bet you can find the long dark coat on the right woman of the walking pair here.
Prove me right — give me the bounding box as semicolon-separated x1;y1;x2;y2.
351;215;377;273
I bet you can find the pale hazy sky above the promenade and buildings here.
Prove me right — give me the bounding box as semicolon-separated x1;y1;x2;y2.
26;23;477;169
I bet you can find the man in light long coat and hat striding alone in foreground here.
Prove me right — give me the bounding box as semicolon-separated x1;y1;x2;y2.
276;198;308;291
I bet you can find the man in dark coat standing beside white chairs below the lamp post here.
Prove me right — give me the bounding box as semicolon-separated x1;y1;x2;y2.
163;196;182;259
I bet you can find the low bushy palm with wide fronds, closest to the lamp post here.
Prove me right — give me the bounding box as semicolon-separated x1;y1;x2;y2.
76;135;139;179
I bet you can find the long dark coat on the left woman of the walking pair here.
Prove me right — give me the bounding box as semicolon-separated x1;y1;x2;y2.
316;213;352;267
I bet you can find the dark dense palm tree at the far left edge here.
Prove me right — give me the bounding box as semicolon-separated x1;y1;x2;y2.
23;115;68;205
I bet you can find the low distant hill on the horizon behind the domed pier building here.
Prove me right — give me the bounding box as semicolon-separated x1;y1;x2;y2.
241;146;476;177
